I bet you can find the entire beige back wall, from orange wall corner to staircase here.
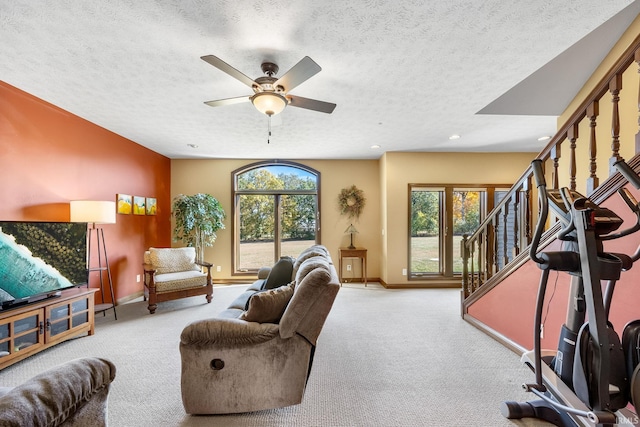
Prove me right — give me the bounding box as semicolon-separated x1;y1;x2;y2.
171;153;534;285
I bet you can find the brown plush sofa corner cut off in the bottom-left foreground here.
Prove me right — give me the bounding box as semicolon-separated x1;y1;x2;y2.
0;357;116;427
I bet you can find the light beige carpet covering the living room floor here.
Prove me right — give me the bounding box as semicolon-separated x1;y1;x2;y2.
0;283;550;427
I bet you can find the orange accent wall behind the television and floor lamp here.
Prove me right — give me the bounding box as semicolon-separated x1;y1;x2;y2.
0;81;171;302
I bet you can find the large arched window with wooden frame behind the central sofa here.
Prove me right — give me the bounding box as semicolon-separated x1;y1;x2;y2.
232;161;320;274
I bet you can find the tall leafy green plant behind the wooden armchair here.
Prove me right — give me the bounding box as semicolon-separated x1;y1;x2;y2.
171;193;226;261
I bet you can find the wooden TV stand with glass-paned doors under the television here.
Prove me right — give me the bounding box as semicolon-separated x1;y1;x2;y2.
0;287;98;370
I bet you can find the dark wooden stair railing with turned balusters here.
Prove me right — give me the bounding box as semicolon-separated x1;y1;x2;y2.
461;31;640;302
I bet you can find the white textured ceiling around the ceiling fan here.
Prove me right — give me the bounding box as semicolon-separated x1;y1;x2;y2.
0;0;640;159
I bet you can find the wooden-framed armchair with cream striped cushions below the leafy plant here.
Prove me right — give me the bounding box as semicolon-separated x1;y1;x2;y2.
144;247;213;314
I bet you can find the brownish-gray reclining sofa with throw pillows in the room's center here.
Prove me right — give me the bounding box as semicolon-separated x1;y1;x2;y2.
180;245;340;414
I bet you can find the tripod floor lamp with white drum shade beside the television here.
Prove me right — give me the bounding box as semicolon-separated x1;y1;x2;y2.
70;200;118;320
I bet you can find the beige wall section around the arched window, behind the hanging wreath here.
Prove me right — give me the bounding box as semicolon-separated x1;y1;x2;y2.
171;160;381;279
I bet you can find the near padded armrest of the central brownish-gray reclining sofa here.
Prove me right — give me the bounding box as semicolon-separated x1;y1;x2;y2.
180;318;279;347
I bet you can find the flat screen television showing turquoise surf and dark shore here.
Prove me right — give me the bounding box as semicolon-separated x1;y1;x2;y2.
0;221;89;310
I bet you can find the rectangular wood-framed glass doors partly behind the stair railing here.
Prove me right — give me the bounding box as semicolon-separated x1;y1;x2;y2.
408;184;504;279
